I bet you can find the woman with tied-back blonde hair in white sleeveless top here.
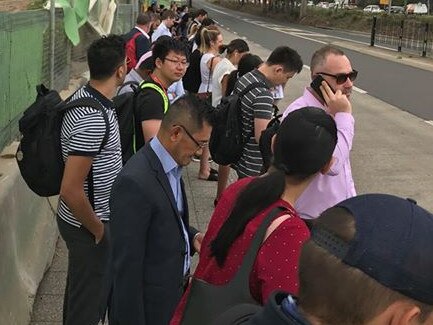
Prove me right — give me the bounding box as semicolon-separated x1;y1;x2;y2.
198;25;223;181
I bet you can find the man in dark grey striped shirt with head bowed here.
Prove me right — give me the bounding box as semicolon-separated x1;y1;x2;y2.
233;46;302;178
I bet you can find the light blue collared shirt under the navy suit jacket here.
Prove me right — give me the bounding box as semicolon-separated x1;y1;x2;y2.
150;137;191;275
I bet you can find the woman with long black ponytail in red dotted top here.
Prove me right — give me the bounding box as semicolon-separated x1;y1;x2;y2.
171;105;342;325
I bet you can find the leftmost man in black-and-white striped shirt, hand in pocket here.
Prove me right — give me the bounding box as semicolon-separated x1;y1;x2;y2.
57;35;127;325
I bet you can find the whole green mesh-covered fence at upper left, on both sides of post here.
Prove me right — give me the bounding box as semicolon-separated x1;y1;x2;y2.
0;1;137;151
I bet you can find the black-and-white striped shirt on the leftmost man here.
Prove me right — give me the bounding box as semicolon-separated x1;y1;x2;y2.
58;85;122;227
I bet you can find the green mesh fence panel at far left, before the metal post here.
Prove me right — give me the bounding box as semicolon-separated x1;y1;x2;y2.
0;11;48;149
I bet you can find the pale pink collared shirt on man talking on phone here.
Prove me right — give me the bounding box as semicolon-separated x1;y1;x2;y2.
282;88;356;219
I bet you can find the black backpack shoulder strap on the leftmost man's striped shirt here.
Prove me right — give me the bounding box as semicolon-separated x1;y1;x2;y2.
63;97;110;211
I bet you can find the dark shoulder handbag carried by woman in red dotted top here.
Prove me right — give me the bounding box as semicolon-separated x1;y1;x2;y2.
181;207;286;325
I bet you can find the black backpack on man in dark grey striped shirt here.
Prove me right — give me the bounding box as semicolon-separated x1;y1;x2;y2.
209;82;268;165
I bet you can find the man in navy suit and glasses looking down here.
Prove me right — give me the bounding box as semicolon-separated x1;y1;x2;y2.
109;95;212;325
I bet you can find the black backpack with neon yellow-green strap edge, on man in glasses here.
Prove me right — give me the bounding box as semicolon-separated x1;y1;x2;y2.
113;81;169;164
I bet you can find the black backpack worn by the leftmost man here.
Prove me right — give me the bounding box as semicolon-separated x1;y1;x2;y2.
16;84;109;197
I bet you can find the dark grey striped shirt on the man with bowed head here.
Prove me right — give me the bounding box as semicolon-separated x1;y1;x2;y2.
233;70;274;178
